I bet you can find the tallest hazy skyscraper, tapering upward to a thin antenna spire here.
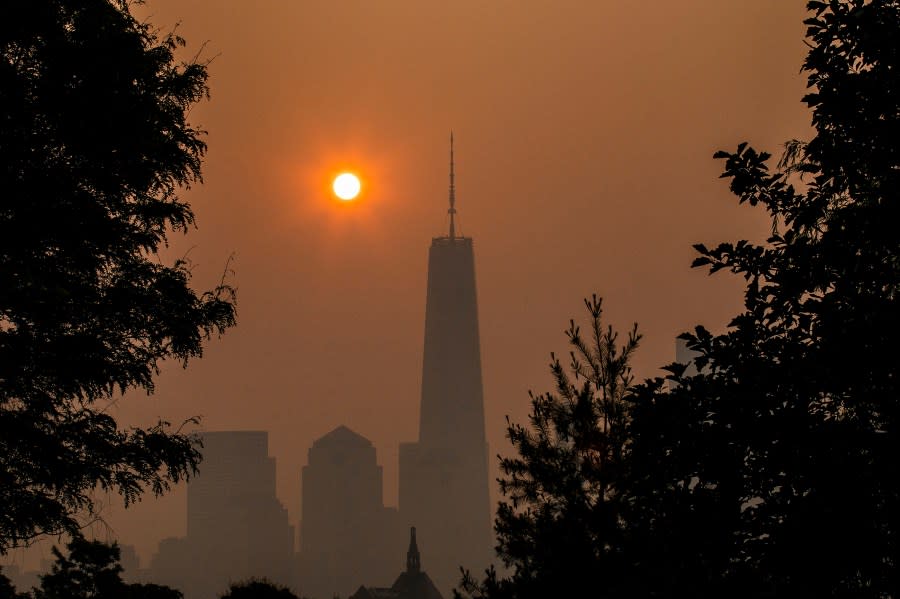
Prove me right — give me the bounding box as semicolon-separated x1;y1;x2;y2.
400;134;493;597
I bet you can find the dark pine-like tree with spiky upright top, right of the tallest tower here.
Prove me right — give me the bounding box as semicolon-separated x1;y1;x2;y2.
463;295;640;598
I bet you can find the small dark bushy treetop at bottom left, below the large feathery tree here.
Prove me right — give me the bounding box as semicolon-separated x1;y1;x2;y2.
34;536;182;599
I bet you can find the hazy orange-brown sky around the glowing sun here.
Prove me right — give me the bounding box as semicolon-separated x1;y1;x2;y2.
7;0;809;568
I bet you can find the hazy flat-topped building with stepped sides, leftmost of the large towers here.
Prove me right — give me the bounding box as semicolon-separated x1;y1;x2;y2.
151;431;294;599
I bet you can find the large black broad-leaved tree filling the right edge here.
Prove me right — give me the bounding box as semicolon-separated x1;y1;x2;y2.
629;0;900;597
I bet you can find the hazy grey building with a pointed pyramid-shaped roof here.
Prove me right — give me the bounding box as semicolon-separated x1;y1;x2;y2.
296;426;403;599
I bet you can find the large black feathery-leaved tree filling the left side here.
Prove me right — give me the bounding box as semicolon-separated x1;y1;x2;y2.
0;0;235;554
